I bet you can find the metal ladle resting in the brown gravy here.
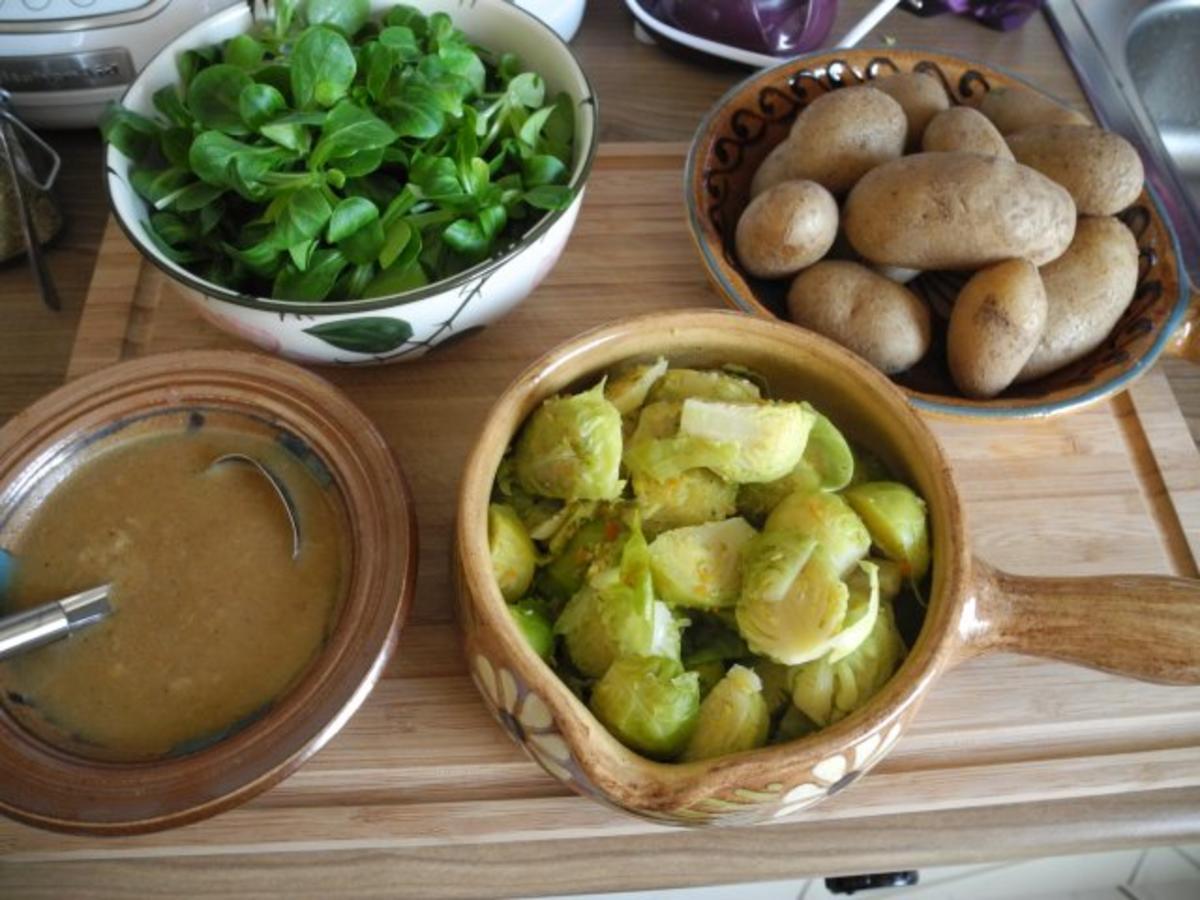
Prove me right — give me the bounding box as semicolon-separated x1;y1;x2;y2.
0;454;300;660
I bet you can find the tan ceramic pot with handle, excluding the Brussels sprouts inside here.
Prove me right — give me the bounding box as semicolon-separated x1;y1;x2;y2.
455;312;1200;824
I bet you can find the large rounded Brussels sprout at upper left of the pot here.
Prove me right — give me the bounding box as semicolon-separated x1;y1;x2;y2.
514;382;624;500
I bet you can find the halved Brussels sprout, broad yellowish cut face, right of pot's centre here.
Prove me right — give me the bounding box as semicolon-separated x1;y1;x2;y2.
737;532;848;666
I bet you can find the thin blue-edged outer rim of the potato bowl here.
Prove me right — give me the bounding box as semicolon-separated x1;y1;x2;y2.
684;47;1190;420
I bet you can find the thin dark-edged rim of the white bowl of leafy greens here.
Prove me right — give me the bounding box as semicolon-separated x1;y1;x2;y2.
101;0;600;316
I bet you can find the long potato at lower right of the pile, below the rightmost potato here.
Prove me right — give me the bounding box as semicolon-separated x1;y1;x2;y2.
1016;218;1138;383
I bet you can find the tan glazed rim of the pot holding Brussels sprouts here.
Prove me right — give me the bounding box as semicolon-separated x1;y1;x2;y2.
455;310;972;824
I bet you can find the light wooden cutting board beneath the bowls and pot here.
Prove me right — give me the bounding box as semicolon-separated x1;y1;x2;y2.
0;144;1200;896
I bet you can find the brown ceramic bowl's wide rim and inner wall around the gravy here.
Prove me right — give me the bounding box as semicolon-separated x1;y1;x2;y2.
0;352;416;834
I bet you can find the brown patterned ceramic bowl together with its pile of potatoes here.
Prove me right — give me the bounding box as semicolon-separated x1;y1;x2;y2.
685;49;1200;418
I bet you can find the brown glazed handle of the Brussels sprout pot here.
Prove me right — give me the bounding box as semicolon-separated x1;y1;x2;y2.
959;560;1200;684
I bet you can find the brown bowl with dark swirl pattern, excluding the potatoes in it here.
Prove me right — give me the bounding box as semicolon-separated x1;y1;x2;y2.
684;49;1200;419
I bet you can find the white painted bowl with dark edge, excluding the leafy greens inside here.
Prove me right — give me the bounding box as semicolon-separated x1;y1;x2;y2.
104;0;598;365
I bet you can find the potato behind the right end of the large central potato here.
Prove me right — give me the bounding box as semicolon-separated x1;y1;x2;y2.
1008;125;1146;216
